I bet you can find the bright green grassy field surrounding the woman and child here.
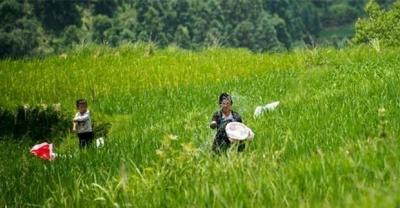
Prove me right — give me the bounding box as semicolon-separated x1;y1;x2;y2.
0;45;400;207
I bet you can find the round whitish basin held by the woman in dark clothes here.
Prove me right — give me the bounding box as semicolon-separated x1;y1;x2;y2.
225;122;254;141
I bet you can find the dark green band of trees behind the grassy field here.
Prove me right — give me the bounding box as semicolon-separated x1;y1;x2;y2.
0;0;400;57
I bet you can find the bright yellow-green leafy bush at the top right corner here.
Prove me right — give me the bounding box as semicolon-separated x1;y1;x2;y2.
353;0;400;46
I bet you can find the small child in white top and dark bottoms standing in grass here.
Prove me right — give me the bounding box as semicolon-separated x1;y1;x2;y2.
73;99;93;149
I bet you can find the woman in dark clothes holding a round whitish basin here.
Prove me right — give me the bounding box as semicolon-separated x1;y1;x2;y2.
210;93;245;153
